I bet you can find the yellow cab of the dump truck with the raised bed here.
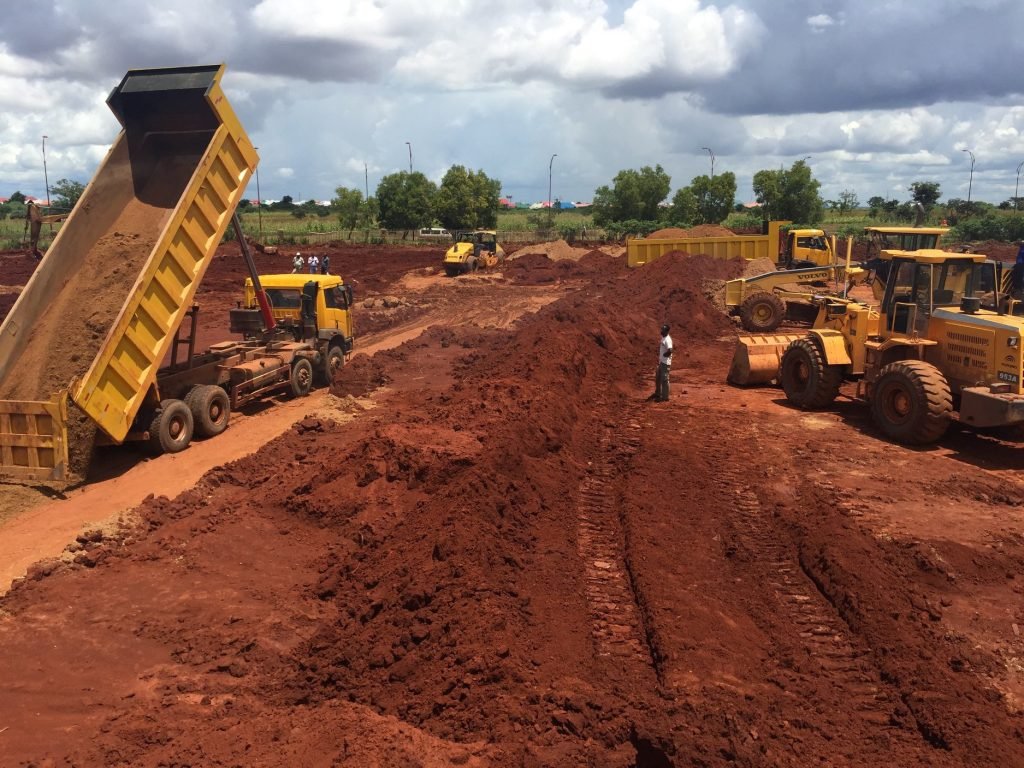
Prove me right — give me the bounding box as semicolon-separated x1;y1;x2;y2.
240;274;355;382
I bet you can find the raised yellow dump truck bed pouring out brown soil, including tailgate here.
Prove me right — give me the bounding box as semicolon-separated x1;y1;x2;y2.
0;65;258;487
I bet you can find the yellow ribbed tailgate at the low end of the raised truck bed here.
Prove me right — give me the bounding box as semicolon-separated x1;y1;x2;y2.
0;391;68;481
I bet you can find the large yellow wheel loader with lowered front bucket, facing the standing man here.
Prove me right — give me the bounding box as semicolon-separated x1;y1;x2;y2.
729;249;1024;444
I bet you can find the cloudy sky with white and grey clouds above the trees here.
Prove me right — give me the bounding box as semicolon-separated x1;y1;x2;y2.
0;0;1024;203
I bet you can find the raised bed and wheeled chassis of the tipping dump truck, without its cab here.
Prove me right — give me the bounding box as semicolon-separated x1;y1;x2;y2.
0;65;350;482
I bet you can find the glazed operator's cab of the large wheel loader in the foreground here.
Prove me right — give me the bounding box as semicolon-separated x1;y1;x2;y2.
881;249;998;337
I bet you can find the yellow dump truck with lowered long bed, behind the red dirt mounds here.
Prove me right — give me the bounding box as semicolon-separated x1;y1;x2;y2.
626;221;836;269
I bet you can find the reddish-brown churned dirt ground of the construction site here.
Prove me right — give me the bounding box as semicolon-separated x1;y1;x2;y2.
0;244;1024;768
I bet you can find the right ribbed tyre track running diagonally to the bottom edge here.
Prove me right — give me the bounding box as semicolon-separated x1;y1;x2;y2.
718;446;922;760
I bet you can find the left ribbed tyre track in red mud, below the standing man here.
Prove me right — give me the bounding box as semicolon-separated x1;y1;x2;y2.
577;407;660;680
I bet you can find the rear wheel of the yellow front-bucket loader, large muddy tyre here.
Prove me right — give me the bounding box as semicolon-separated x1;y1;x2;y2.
871;360;953;445
